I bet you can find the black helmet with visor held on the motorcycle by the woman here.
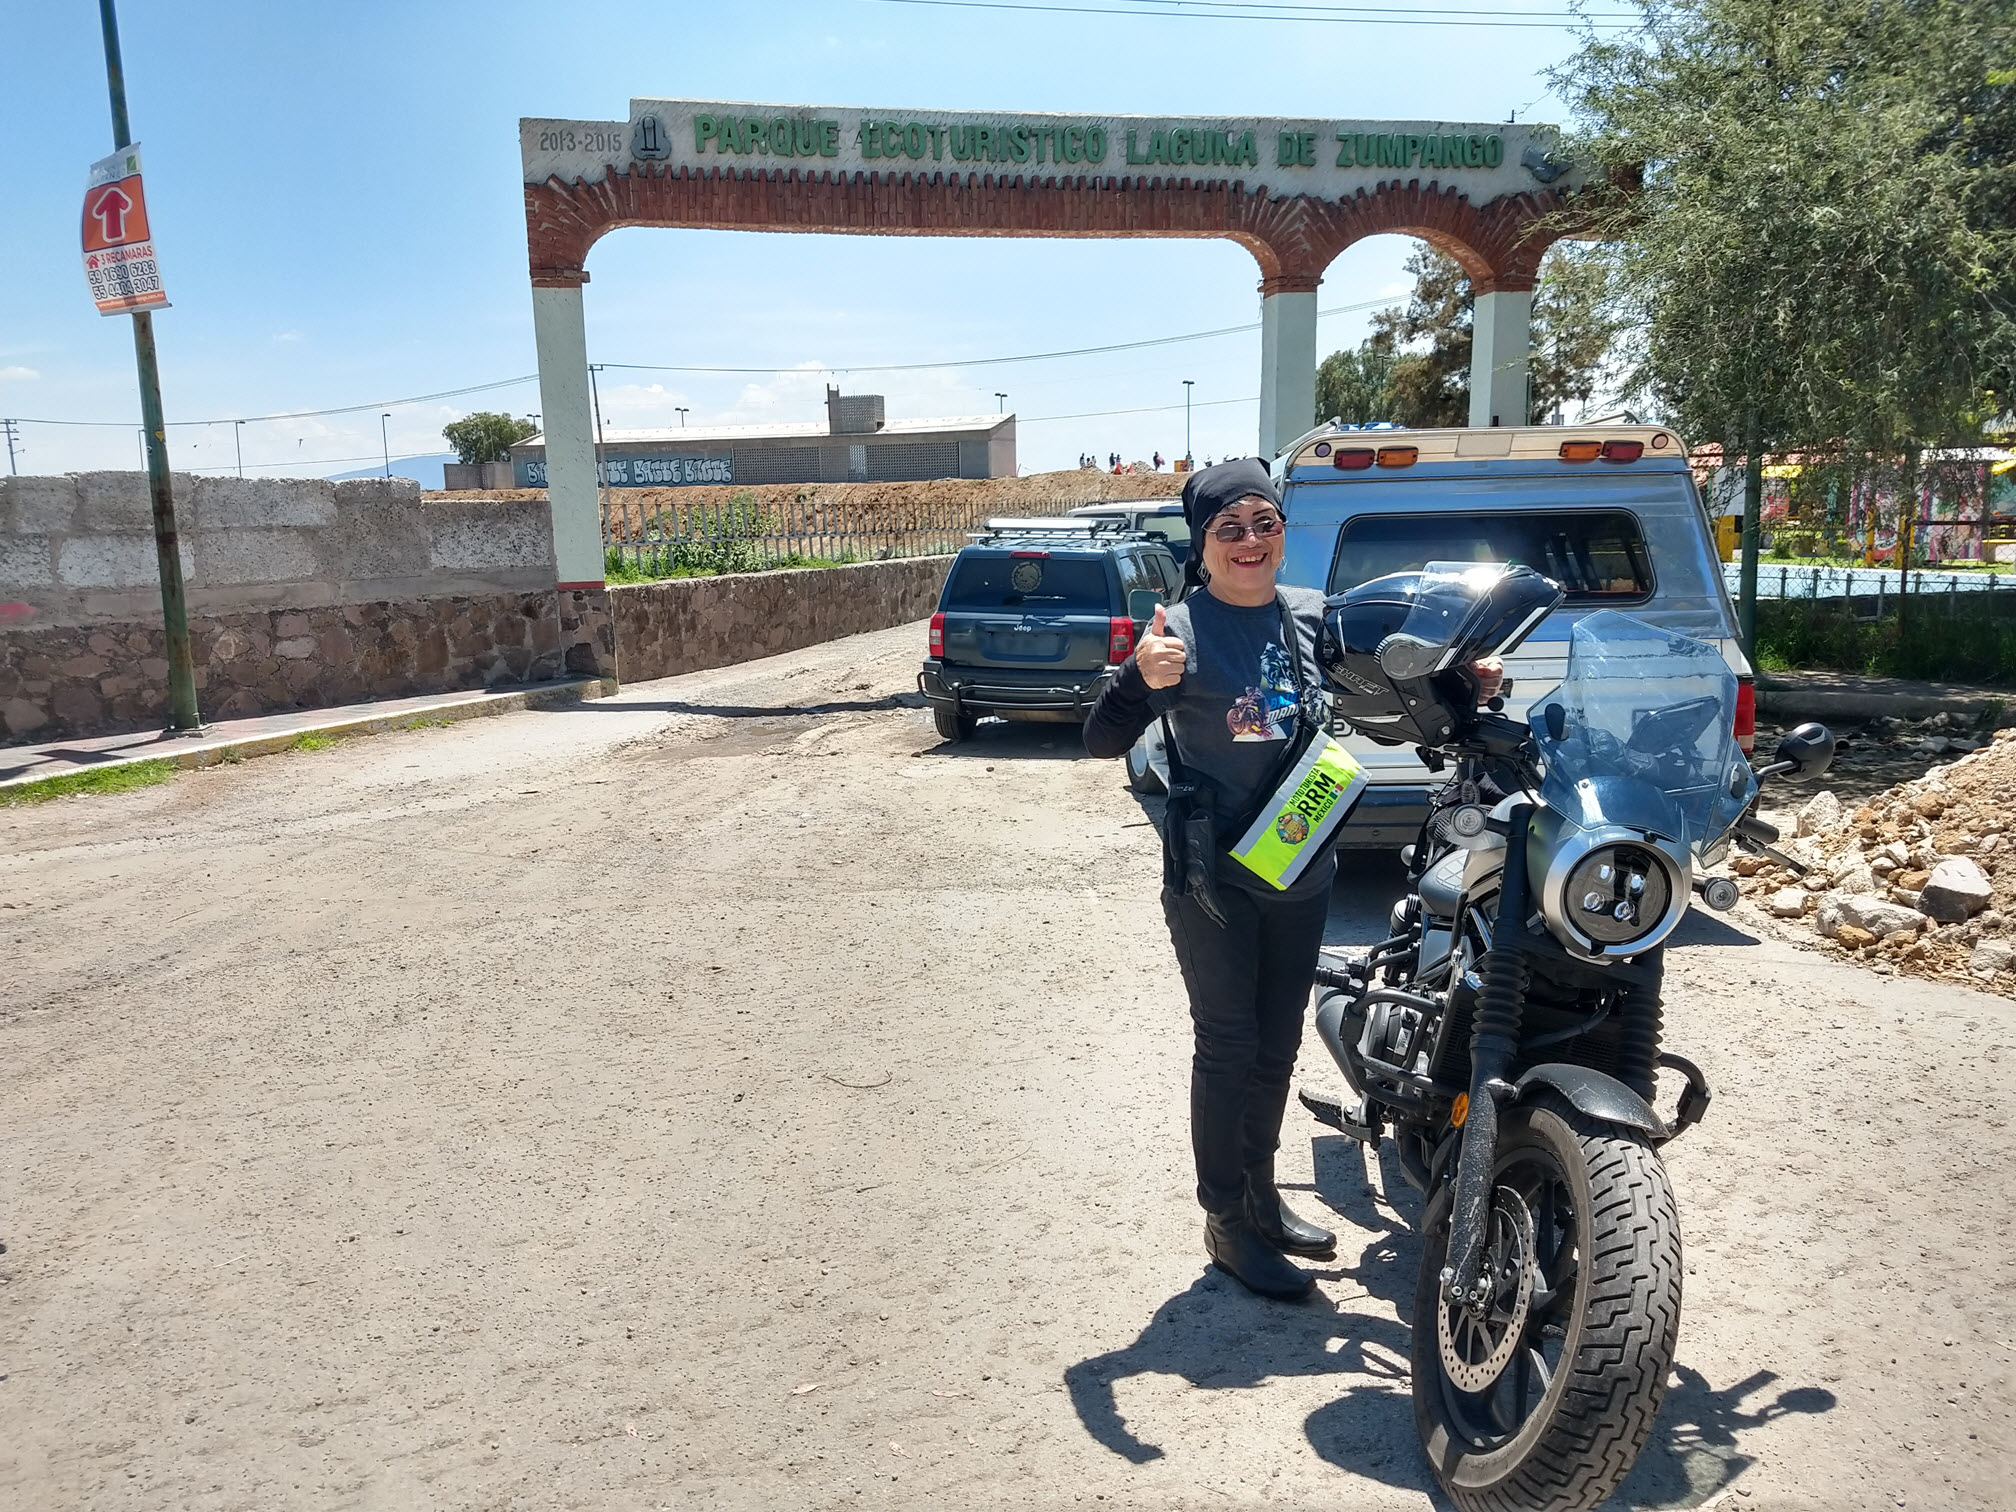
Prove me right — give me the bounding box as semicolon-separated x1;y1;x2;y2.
1318;562;1566;748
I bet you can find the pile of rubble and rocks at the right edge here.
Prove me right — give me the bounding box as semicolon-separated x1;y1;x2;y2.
1730;730;2016;992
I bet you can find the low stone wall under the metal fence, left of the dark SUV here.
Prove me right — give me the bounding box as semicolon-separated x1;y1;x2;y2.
609;556;952;681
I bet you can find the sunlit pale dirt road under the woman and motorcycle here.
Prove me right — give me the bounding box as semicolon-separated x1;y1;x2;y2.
0;627;2016;1512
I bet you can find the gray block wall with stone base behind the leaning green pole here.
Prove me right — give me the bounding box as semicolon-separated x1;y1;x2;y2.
0;472;568;742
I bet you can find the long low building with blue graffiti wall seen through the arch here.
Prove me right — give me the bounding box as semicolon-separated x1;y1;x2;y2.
510;387;1016;488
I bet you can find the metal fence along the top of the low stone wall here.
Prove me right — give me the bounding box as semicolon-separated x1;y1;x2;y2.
603;490;1089;577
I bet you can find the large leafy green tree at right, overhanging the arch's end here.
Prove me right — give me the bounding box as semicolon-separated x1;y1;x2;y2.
1554;0;2016;633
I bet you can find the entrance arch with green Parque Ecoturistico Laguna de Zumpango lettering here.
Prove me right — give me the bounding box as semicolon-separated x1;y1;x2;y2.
518;99;1583;611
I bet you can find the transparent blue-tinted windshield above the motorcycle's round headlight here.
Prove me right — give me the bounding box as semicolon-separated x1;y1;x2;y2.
1528;609;1758;849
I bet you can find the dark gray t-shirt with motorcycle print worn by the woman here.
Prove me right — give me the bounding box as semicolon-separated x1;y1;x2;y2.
1151;587;1337;897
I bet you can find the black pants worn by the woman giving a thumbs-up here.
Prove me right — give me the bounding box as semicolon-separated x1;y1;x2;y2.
1161;883;1331;1214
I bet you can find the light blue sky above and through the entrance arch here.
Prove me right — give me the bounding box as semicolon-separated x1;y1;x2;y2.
0;0;1604;476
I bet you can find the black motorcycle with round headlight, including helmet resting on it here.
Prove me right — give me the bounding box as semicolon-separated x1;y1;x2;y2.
1302;562;1835;1512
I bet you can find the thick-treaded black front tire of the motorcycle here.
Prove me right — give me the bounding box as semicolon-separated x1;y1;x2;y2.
1413;1099;1681;1512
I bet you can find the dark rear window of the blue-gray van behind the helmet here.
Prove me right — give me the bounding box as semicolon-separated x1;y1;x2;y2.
1331;510;1653;605
